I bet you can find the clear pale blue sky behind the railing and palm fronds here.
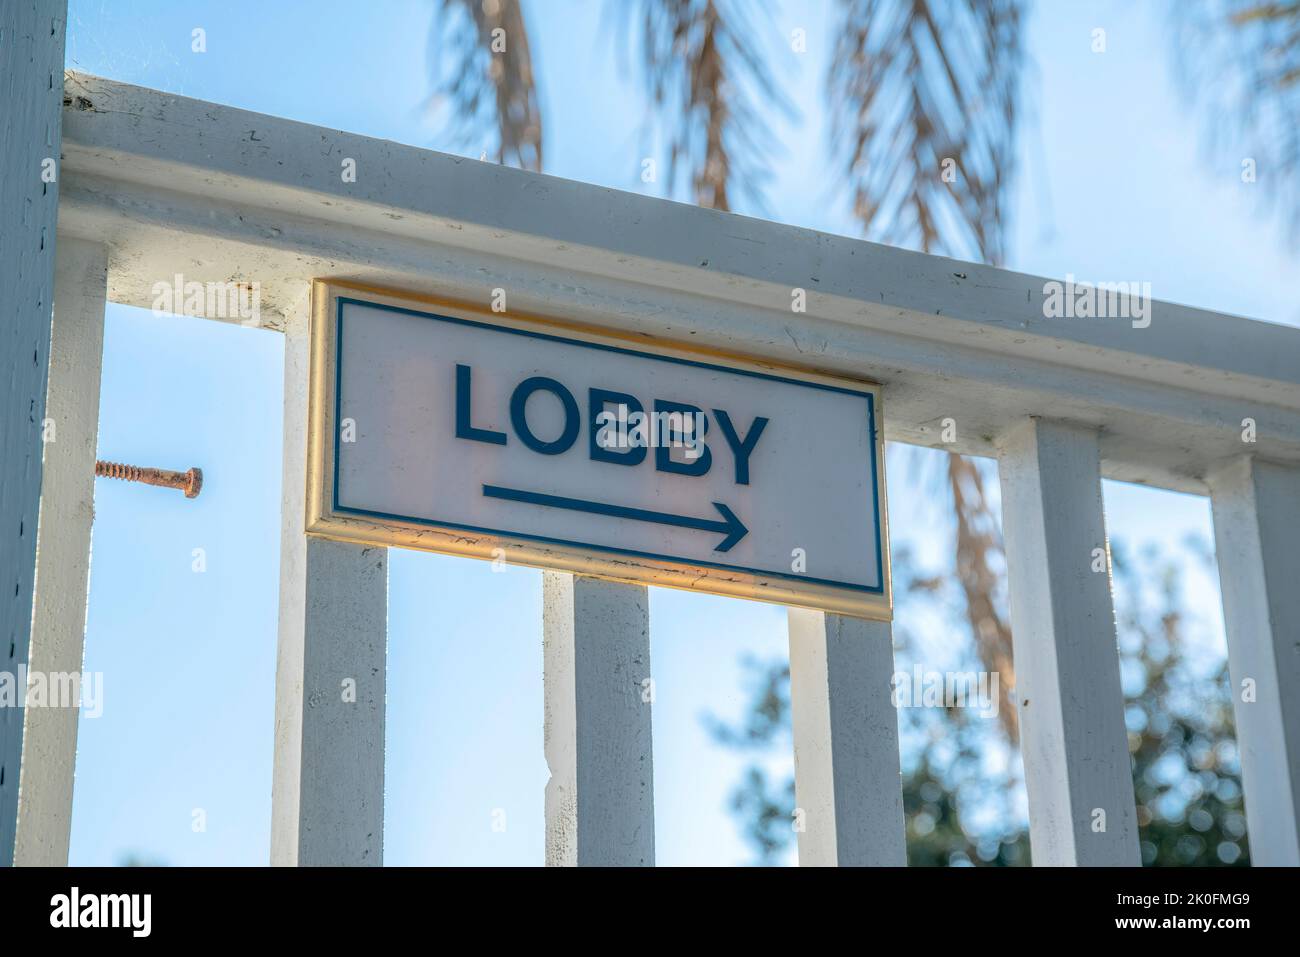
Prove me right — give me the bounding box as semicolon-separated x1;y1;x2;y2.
58;0;1300;865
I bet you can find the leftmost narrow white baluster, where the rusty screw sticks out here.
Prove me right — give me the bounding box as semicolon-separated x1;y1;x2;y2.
14;239;108;867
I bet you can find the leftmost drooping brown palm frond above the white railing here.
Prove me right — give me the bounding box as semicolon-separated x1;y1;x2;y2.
429;0;542;170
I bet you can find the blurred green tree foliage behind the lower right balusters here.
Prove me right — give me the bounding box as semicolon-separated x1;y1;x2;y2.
711;530;1249;866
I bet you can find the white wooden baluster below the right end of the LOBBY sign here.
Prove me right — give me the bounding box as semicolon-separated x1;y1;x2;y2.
788;609;907;867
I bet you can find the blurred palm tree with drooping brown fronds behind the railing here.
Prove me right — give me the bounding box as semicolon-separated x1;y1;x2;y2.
430;0;1300;858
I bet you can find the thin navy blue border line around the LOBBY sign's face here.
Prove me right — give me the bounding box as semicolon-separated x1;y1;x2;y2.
333;295;885;596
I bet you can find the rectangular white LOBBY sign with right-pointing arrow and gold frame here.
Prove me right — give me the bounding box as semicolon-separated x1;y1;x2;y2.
308;283;889;618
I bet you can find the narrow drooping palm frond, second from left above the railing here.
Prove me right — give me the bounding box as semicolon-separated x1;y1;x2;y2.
612;0;793;209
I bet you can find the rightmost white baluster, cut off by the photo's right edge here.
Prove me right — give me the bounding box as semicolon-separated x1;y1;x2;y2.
1210;456;1300;867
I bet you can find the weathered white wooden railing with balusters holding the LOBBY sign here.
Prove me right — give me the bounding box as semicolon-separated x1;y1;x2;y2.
0;57;1300;865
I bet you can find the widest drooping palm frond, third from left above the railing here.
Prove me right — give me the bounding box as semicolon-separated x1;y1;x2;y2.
827;0;1022;264
